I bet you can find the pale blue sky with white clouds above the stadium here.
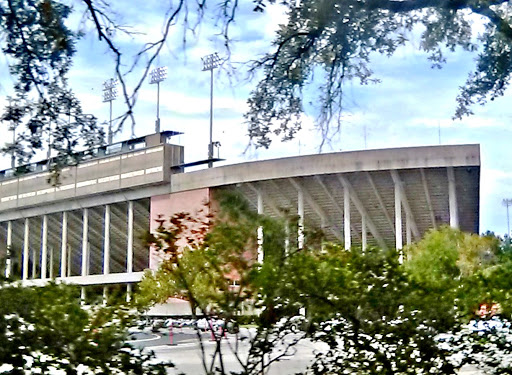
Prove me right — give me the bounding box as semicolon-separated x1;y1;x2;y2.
0;0;512;234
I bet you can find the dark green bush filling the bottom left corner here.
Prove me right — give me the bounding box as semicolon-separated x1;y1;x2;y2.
0;284;172;375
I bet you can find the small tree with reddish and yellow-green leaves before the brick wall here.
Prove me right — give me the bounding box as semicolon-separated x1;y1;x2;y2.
138;194;270;317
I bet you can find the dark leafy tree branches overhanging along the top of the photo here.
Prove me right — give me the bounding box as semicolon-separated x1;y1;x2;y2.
0;0;512;163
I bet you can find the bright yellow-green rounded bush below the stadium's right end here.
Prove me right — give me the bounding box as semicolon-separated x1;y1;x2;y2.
405;227;512;329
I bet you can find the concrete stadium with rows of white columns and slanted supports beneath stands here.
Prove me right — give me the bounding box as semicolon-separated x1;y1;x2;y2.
0;132;480;306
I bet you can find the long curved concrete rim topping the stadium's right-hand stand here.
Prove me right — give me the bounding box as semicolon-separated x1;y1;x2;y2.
171;145;480;192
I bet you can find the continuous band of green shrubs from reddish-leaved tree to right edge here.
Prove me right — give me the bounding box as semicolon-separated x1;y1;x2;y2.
142;200;512;374
